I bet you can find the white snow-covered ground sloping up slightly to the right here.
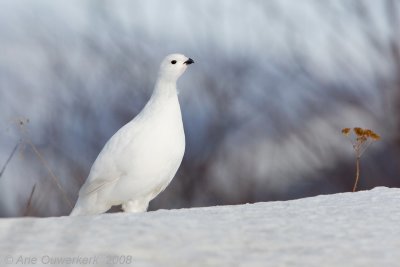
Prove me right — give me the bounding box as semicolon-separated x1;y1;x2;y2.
0;187;400;267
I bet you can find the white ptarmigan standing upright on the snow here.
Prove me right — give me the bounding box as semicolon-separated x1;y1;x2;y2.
70;54;194;216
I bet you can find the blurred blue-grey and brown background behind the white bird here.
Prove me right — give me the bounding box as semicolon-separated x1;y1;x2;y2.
0;0;400;217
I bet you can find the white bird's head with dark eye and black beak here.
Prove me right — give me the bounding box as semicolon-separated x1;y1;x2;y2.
158;54;194;82
